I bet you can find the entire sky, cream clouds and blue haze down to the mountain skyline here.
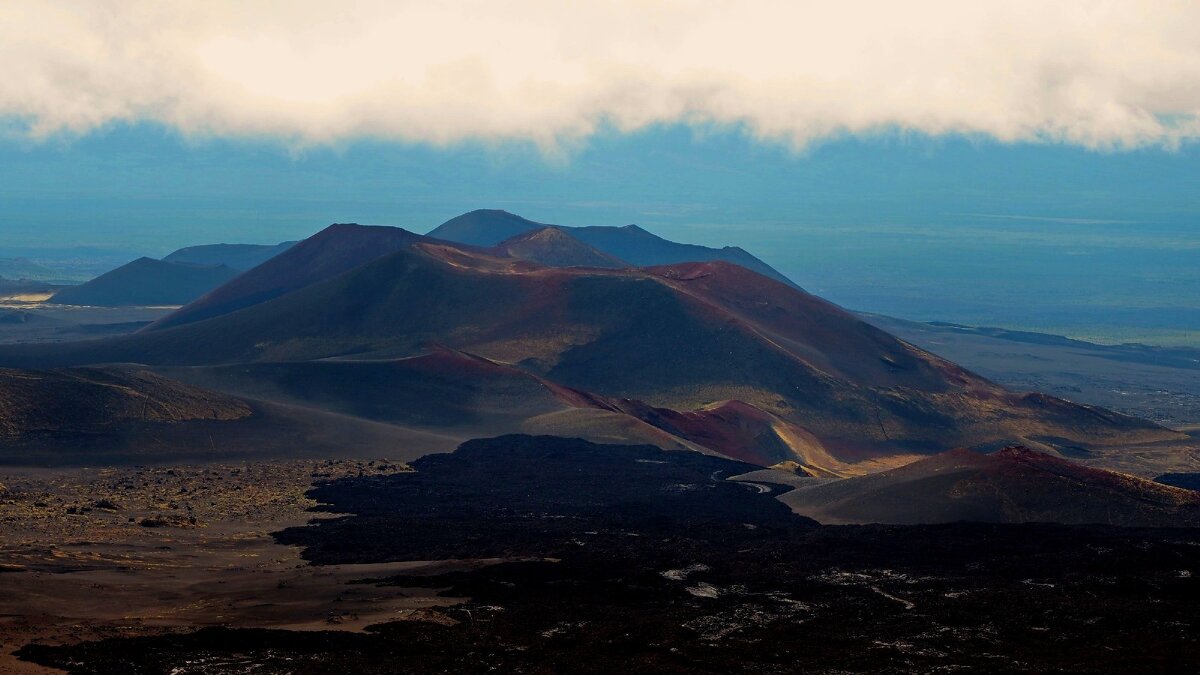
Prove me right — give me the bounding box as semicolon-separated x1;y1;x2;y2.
0;0;1200;341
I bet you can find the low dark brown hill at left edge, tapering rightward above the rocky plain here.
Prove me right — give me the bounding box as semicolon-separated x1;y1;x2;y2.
0;368;453;466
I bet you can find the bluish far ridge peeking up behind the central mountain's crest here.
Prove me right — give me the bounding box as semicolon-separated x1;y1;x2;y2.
428;209;796;286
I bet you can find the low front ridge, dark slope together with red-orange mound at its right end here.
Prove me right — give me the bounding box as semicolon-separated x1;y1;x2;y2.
157;347;859;474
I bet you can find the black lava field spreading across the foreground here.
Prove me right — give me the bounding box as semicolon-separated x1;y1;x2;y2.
20;436;1200;675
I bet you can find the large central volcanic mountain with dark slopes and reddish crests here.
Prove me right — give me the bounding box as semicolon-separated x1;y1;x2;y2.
0;226;1181;474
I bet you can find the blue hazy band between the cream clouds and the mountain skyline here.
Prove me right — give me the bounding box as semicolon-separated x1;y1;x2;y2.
0;125;1200;341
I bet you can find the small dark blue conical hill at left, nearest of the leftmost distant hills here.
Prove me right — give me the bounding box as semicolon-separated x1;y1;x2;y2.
50;258;238;307
